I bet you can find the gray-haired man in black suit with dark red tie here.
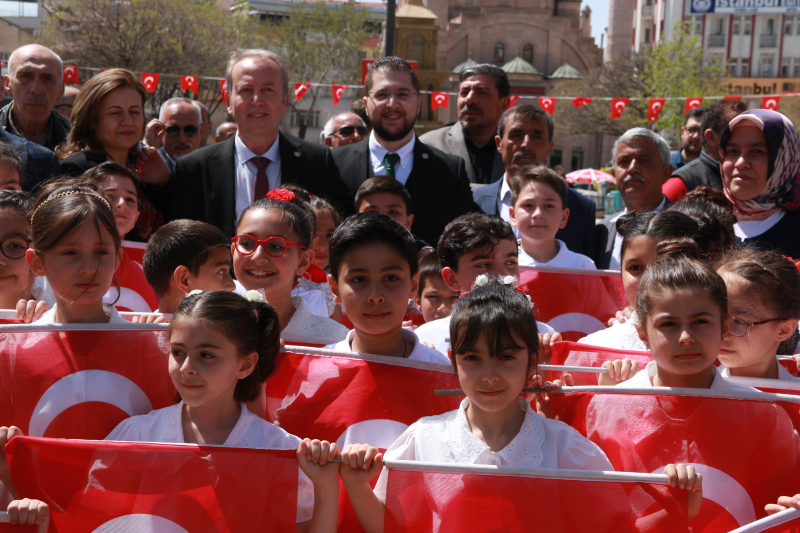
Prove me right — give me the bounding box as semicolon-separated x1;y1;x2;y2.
167;49;354;237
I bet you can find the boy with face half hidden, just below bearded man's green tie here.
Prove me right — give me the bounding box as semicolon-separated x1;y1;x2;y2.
355;176;433;260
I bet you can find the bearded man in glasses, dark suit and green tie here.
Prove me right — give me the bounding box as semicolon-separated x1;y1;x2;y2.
333;57;478;244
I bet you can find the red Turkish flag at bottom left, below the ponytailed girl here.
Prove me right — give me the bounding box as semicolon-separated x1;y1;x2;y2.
6;437;298;533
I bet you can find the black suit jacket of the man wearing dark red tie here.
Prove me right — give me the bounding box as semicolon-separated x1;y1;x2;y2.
167;133;353;237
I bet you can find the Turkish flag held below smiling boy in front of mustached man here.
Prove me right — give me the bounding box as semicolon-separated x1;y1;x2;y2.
520;267;628;340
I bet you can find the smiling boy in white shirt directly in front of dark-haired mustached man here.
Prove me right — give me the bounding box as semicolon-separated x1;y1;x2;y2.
509;165;597;270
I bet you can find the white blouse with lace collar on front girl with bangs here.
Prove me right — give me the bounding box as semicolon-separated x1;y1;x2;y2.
374;398;614;502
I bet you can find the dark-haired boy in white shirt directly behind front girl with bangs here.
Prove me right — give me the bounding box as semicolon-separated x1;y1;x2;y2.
415;213;561;355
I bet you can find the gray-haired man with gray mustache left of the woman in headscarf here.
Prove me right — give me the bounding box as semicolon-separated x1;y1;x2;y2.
595;128;672;269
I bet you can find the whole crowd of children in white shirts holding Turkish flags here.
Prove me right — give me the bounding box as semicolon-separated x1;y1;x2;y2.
0;109;800;532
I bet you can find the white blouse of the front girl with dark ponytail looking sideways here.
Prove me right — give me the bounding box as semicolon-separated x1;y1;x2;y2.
105;402;314;523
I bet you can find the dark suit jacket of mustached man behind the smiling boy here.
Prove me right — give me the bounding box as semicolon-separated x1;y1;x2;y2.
472;178;597;259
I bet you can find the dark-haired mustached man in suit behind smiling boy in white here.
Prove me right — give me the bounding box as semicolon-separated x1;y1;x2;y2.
472;104;596;259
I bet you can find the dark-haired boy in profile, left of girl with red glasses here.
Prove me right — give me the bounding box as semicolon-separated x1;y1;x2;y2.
142;219;235;313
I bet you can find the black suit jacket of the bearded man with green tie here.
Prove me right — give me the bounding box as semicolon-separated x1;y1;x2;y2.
333;139;478;245
